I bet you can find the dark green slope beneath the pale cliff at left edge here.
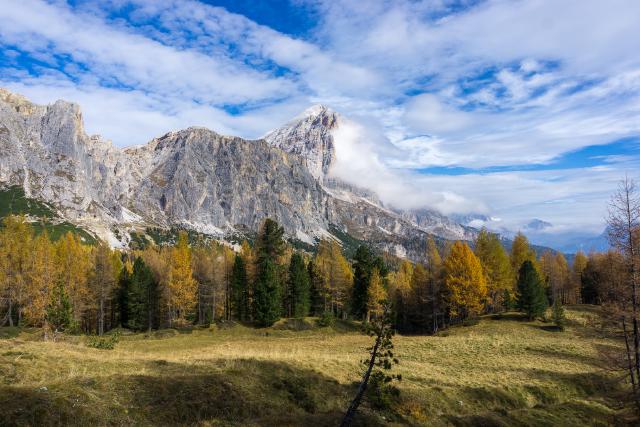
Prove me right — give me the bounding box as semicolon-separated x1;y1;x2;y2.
0;186;96;244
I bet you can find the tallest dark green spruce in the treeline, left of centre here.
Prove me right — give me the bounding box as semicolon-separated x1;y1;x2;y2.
253;218;284;326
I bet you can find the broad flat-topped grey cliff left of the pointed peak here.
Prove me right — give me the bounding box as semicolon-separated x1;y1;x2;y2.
129;128;328;239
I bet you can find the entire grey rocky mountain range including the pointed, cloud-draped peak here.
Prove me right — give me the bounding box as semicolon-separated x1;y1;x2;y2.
0;89;473;259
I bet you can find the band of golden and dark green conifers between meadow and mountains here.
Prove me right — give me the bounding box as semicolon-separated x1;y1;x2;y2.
0;217;600;334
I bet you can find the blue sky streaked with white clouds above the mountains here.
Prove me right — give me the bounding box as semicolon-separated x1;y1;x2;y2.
0;0;640;249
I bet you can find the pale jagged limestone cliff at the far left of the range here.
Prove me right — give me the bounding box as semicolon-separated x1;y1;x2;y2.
0;89;136;237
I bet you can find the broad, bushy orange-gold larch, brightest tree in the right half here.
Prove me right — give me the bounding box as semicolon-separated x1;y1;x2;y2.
444;241;487;320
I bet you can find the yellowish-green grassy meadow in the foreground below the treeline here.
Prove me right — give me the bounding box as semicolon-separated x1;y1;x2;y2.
0;309;632;426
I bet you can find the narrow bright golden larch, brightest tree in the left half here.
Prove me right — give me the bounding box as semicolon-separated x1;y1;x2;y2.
169;231;198;322
